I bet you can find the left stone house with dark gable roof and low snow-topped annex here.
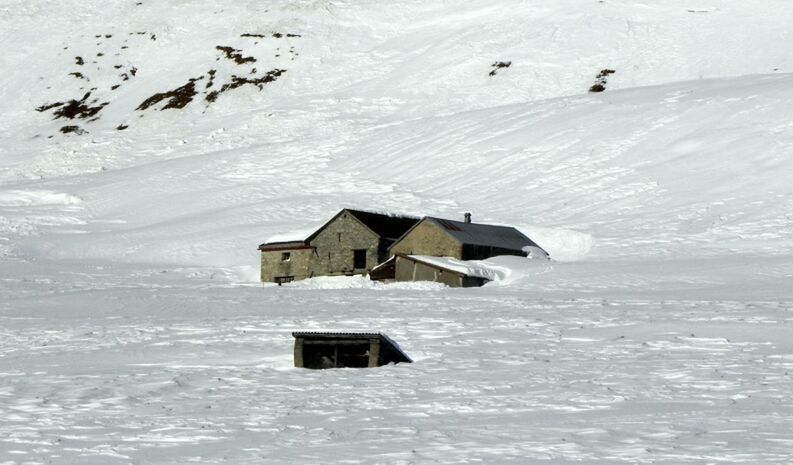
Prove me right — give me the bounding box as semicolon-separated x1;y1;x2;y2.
259;208;419;284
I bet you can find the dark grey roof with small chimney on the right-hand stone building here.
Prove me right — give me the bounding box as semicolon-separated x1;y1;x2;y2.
425;216;540;250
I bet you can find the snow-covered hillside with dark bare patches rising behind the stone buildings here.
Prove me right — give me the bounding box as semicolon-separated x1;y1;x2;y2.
0;2;793;267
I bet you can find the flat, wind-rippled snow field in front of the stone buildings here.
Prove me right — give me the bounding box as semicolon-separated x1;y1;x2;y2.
0;263;793;464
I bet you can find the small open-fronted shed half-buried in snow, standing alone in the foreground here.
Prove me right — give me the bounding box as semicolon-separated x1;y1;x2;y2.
292;331;413;369
